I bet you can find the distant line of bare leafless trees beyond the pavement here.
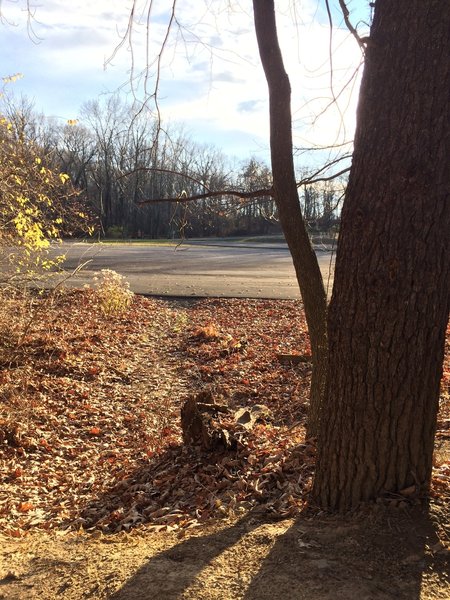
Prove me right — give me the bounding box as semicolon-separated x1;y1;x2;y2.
0;95;342;238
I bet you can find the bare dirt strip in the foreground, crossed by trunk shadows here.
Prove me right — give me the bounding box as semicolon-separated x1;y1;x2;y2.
0;507;450;600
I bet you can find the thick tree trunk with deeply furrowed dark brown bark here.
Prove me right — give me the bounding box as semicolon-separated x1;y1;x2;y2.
314;0;450;509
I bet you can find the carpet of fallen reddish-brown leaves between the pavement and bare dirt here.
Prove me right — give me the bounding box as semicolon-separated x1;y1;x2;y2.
0;290;450;537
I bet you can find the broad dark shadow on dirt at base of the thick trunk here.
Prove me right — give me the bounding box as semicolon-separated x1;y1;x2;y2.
243;507;448;600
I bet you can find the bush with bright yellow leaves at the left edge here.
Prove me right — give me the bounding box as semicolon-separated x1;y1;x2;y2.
0;115;88;276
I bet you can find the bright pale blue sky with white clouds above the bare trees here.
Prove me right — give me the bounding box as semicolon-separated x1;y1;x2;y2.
0;0;370;162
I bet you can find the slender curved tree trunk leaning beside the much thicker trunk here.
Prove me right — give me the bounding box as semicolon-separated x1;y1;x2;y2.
253;0;327;435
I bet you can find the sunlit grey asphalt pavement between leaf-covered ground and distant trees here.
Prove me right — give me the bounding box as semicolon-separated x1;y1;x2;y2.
53;242;333;298
